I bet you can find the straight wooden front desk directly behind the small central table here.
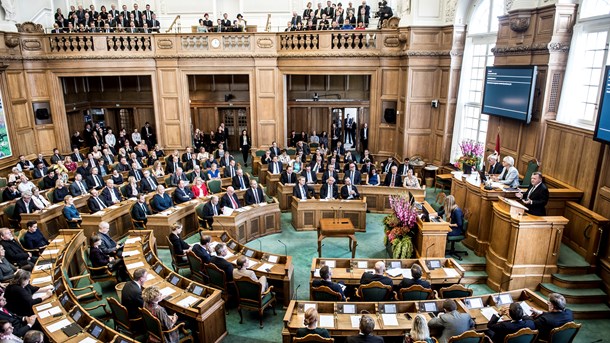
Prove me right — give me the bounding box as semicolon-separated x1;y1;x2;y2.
291;197;367;232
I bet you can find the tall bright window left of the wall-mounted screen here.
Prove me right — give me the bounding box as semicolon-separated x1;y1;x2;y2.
451;0;504;161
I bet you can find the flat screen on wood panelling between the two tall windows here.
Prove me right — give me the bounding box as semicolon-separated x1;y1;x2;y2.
481;66;538;124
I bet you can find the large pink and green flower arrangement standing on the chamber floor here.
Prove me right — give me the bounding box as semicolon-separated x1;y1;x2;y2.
383;194;418;259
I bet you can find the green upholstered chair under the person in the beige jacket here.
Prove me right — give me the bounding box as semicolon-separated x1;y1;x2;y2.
234;277;276;329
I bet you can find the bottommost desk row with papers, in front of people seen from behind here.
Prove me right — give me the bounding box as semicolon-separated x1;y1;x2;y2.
282;289;547;343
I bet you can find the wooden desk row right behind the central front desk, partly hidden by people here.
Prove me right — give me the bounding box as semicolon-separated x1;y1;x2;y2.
276;182;426;213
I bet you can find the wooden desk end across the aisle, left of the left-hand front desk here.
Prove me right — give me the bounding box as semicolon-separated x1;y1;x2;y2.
146;199;201;248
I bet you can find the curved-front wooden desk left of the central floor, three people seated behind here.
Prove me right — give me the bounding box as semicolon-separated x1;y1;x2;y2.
212;202;282;244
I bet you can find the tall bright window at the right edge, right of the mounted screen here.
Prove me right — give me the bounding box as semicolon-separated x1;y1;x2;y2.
557;0;610;128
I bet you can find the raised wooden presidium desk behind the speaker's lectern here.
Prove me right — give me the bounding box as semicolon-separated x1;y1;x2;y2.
451;173;583;256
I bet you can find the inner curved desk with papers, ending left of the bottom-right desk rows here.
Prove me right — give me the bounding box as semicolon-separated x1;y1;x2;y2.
206;231;294;307
